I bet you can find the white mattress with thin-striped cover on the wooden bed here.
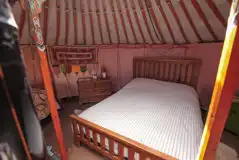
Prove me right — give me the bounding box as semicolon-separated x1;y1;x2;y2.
79;78;203;160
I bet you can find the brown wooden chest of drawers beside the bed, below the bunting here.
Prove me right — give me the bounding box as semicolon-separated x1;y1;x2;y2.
77;79;112;104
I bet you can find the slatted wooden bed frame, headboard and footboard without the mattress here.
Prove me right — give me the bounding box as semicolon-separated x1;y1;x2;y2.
70;57;201;160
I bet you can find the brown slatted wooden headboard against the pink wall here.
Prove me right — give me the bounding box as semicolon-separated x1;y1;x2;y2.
133;57;201;89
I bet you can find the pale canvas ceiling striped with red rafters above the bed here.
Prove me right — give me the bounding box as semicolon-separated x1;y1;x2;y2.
13;0;230;45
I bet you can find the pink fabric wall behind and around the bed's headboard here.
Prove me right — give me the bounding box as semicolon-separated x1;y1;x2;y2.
98;43;223;107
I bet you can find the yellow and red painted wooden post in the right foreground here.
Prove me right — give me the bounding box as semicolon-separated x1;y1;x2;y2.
198;0;239;160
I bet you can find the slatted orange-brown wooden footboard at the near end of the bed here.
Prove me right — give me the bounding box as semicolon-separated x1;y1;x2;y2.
70;115;176;160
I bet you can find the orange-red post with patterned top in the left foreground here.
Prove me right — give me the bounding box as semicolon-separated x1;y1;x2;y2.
28;0;67;160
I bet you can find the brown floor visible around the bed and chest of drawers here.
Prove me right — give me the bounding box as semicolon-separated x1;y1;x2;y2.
43;99;239;160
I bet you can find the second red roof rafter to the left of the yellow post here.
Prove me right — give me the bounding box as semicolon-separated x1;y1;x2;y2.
192;0;218;41
